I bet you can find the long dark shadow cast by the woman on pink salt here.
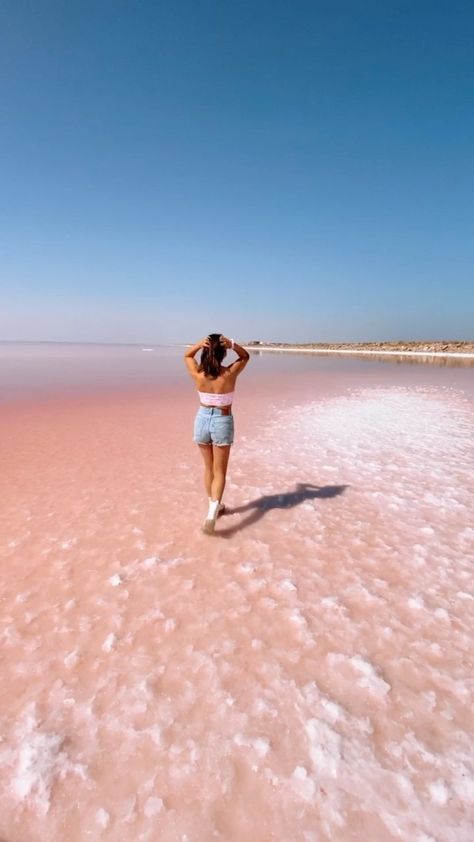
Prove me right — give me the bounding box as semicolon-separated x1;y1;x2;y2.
215;482;349;538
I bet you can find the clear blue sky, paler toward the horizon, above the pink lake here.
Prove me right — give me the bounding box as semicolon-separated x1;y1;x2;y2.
0;0;474;342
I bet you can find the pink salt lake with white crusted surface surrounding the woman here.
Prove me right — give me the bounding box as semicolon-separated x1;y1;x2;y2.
0;346;474;842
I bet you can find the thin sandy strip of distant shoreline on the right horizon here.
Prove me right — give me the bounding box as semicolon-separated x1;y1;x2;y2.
244;342;474;359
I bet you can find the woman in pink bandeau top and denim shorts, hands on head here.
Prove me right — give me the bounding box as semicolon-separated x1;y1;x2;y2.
184;333;250;535
